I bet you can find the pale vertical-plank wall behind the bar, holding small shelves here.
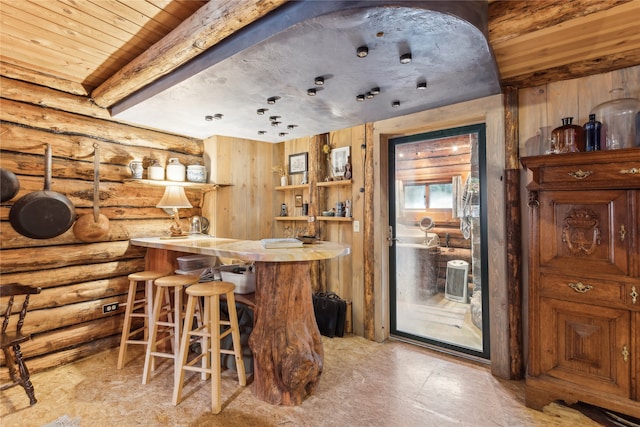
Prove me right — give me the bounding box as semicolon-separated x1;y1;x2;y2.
203;126;365;335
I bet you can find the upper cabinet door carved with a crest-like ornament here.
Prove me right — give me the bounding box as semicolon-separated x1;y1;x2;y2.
539;190;632;276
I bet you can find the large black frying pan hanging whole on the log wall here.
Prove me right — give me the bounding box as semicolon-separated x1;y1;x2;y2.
9;144;76;239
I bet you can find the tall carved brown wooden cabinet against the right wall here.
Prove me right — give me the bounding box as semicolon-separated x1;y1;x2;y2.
522;149;640;417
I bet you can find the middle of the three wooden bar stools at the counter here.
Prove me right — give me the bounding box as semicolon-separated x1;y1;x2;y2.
142;274;200;384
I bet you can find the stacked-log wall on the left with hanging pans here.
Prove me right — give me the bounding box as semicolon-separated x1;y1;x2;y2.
0;77;204;380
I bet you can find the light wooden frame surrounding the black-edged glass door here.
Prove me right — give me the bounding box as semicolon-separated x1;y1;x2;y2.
366;94;510;378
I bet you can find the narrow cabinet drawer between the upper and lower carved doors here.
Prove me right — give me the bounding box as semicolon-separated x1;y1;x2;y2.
540;273;627;307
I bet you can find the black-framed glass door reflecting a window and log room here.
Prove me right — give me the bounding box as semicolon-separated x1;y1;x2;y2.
389;124;489;359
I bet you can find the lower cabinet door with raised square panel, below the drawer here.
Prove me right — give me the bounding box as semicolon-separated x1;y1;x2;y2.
539;298;633;398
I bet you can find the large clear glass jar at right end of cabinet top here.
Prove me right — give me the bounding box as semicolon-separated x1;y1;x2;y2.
591;88;640;150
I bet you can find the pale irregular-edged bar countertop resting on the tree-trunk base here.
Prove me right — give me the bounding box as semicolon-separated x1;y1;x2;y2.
131;235;351;262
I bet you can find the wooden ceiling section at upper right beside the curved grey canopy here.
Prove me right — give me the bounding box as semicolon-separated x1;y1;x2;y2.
489;0;640;87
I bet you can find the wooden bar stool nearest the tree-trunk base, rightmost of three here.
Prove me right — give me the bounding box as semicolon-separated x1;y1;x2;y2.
173;282;247;414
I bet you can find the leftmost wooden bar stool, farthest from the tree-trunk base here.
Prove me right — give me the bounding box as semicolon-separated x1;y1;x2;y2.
117;270;170;369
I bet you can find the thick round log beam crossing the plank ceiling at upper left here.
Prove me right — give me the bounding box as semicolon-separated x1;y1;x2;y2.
91;0;287;108
